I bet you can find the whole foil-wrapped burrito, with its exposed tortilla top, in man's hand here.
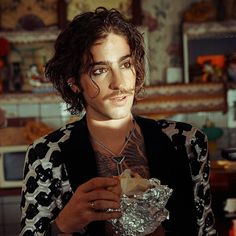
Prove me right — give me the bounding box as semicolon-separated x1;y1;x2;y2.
110;169;172;236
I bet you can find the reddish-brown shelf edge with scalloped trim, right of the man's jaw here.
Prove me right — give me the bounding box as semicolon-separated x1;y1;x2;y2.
134;83;227;118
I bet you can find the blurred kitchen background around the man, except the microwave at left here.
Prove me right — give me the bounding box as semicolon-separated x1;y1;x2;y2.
0;0;236;236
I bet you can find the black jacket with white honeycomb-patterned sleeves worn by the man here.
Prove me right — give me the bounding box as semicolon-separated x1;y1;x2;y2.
20;117;217;236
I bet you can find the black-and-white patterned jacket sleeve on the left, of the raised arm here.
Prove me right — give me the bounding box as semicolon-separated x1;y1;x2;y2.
20;136;72;236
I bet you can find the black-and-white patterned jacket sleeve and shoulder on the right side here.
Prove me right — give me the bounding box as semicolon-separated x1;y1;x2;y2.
159;120;217;236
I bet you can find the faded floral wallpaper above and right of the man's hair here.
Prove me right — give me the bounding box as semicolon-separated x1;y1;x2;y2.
68;0;192;85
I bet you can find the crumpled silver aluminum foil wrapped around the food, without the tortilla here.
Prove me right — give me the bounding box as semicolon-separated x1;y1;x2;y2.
111;179;172;236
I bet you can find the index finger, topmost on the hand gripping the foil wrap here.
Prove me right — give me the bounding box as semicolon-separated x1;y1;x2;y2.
78;177;119;192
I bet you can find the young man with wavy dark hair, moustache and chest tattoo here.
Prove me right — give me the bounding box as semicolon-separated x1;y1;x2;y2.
21;8;215;236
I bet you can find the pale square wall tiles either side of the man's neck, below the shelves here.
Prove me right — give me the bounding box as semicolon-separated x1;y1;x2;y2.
0;103;228;128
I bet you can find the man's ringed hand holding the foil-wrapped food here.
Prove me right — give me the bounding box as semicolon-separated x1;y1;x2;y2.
56;177;121;233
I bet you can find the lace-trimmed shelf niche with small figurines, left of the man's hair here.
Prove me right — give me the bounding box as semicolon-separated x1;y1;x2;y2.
0;30;59;93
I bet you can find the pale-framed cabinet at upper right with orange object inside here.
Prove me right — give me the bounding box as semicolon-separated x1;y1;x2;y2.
183;20;236;86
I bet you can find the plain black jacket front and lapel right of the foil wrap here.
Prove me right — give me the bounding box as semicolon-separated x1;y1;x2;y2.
137;118;196;235
